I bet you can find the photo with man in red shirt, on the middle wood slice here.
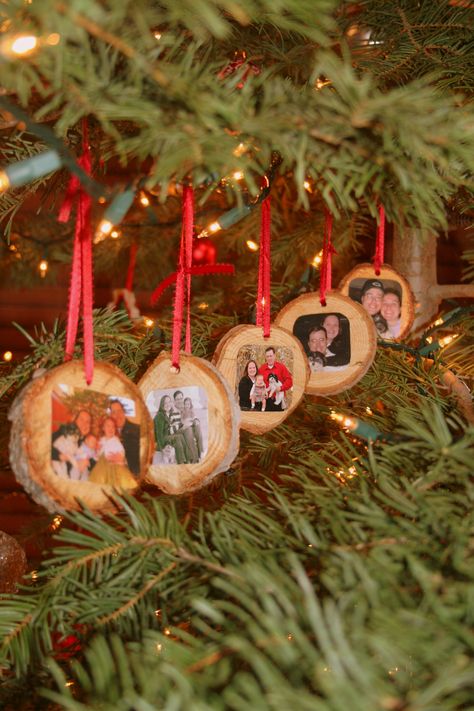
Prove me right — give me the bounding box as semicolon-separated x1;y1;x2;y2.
236;345;293;412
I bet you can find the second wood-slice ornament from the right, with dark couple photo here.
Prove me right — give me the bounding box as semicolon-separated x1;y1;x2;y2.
275;291;377;395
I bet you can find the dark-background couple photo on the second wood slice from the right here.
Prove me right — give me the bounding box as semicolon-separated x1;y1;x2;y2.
293;313;351;373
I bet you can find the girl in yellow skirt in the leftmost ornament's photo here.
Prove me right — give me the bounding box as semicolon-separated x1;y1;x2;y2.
89;417;136;489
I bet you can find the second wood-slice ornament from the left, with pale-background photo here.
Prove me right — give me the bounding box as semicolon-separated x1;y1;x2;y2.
138;353;240;494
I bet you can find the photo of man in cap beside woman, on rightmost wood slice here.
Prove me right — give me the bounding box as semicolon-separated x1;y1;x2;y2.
349;277;402;340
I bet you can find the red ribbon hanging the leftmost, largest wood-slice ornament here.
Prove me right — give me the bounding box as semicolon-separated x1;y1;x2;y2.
58;120;94;385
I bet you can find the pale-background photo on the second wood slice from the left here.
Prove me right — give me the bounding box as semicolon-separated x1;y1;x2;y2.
146;385;209;465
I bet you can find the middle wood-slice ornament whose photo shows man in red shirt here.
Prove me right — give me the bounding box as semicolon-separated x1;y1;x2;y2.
213;325;309;434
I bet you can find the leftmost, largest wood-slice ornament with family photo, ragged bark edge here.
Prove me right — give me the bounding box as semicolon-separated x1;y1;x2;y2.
8;360;151;513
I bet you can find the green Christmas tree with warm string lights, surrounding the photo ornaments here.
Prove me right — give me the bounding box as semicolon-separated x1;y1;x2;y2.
0;0;474;711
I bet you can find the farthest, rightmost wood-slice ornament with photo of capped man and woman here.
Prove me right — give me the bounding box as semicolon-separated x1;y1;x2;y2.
339;263;415;341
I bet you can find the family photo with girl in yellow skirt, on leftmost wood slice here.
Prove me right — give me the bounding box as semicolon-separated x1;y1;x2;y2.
51;384;140;489
